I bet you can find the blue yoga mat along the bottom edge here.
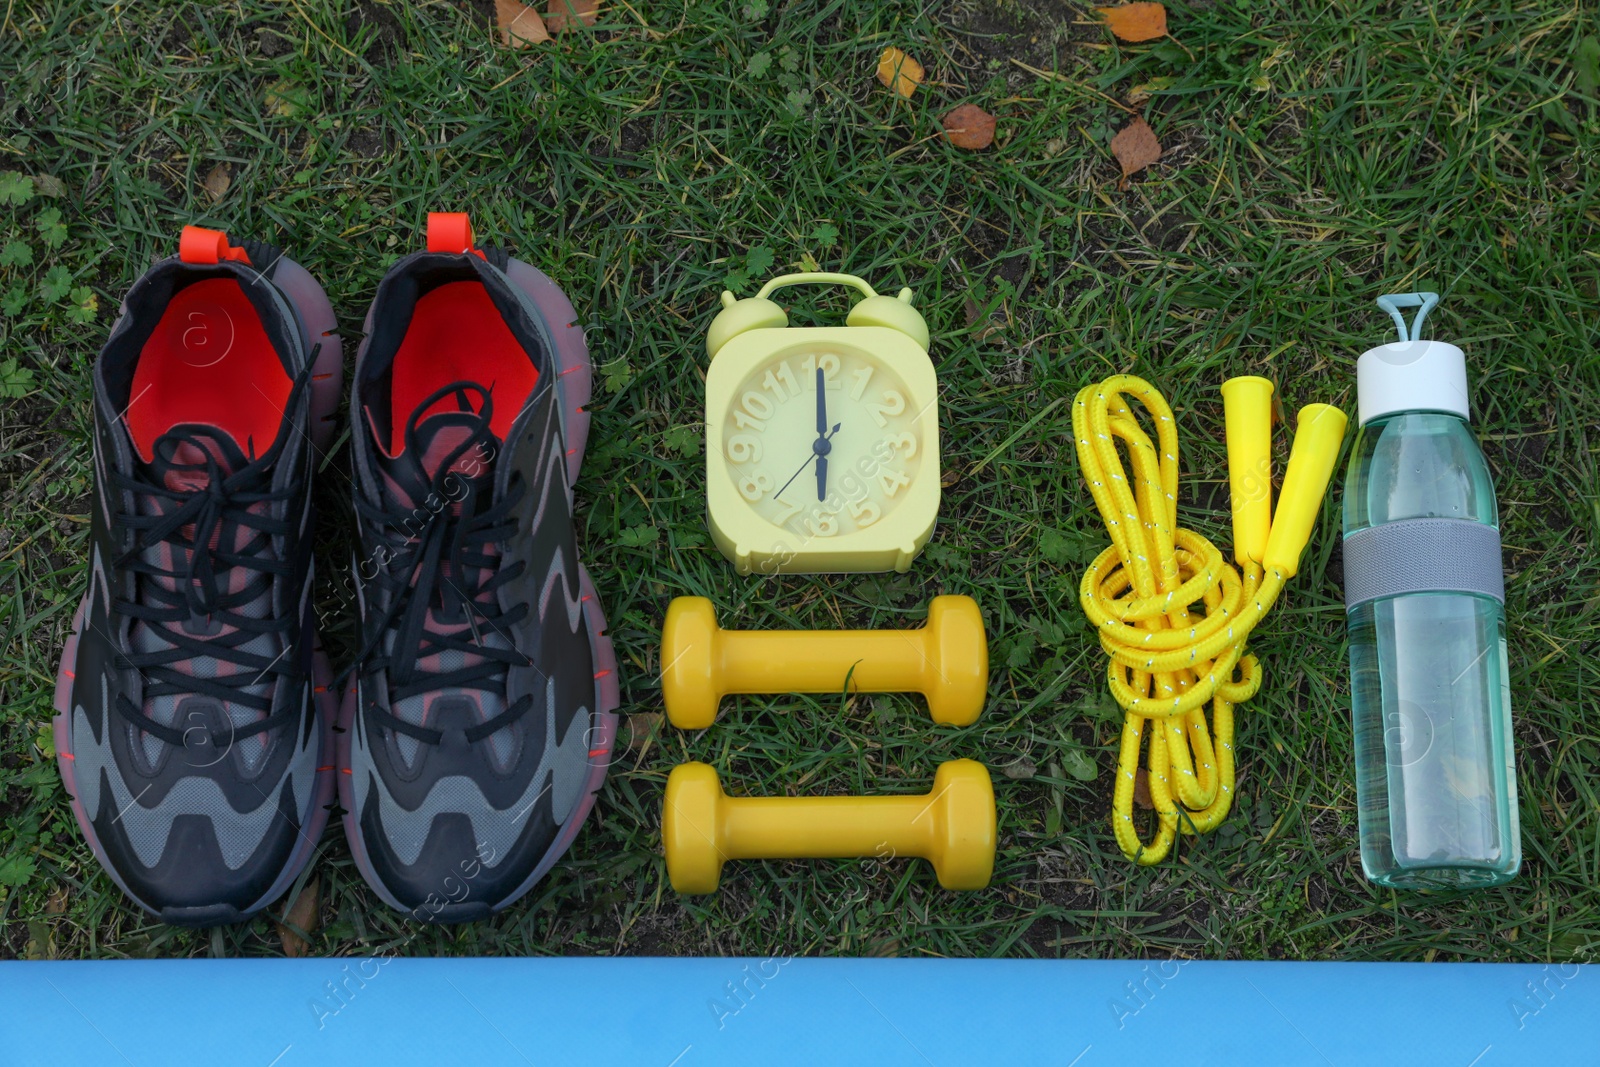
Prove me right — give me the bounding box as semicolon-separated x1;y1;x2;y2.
0;957;1600;1067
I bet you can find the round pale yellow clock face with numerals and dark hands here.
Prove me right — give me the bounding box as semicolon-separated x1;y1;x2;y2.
722;344;938;541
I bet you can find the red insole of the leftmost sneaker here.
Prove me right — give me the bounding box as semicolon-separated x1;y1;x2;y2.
125;278;291;462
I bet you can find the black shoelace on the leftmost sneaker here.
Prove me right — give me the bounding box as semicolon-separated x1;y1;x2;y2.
110;349;317;747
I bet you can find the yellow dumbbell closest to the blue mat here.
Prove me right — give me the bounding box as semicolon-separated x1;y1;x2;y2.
661;760;995;893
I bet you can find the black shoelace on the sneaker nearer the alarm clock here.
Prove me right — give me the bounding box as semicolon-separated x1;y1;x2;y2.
355;382;533;745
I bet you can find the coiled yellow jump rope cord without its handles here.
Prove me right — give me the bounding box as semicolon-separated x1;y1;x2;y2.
1072;374;1280;865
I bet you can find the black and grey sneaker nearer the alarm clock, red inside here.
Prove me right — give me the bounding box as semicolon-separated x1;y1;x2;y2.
339;214;618;921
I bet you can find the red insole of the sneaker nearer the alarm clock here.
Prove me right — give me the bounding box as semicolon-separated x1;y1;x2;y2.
389;282;539;454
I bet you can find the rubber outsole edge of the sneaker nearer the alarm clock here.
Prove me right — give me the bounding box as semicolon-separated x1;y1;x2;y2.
338;259;622;923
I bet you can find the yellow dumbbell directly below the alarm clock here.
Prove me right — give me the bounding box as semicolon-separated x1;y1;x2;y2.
661;597;989;729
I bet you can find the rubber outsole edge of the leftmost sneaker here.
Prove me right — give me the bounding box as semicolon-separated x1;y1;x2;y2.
51;256;344;926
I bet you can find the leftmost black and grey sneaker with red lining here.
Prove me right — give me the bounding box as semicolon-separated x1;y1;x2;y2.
54;227;342;926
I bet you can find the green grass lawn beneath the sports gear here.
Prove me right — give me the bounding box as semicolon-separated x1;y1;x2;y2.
0;0;1600;960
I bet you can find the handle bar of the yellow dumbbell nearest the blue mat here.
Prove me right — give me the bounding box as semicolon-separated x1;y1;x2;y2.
717;795;938;859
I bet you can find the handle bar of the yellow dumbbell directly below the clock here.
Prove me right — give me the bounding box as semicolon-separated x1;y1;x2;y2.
717;630;936;693
